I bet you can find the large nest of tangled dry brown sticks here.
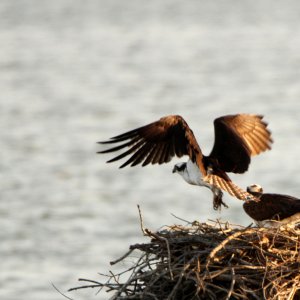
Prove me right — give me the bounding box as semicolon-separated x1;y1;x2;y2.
71;221;300;300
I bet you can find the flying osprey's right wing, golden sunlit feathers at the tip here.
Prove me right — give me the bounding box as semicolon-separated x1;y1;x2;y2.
209;114;273;173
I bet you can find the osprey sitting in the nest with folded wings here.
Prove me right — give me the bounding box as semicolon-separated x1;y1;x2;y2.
243;184;300;227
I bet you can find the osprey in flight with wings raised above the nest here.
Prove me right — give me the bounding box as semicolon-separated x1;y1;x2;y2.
98;114;272;209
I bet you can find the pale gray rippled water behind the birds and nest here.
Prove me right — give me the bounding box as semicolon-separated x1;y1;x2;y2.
0;0;300;300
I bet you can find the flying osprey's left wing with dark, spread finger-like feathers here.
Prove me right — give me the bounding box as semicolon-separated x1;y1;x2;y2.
98;115;205;174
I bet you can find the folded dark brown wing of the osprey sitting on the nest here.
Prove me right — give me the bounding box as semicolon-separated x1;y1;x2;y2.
243;194;300;221
